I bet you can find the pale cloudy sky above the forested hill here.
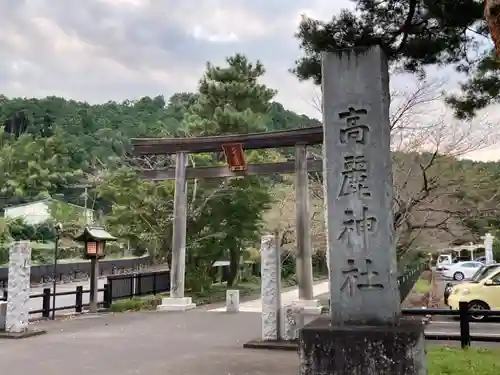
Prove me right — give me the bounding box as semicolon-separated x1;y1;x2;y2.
0;0;496;158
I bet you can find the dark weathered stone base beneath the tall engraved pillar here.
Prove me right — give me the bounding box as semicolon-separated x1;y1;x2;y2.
299;317;427;375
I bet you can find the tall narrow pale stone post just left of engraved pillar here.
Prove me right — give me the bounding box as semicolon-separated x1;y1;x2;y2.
260;235;281;340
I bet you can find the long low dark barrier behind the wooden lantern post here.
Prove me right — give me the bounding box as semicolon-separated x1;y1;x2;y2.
0;256;152;288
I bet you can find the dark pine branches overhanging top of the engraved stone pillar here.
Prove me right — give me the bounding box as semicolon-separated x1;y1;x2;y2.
293;0;492;118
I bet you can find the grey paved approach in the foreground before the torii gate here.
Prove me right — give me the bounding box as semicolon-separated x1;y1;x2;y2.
0;310;299;375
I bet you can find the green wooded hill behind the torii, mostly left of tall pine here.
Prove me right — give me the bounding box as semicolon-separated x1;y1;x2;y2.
0;93;320;209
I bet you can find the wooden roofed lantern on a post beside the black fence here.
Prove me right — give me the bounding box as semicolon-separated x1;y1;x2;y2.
75;226;116;313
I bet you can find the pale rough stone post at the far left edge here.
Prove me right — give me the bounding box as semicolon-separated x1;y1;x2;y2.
5;241;31;334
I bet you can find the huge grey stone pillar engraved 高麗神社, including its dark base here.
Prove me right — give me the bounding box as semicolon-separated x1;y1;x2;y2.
300;47;427;375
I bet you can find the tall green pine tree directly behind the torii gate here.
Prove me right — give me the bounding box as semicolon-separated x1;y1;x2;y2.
184;54;276;286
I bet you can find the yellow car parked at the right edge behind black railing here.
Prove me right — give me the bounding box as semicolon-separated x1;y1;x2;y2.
448;269;500;321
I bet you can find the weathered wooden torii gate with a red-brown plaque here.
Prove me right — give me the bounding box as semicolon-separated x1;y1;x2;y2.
132;126;323;311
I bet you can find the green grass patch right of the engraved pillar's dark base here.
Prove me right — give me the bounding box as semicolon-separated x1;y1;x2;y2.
427;347;500;375
